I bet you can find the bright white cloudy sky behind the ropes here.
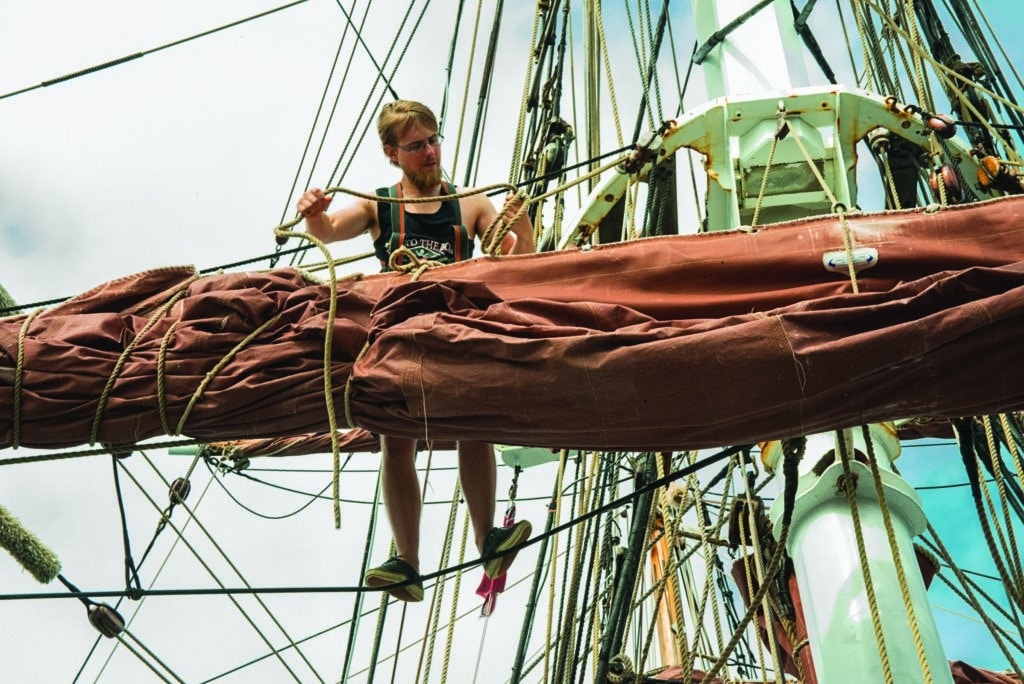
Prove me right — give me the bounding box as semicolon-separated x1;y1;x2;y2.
0;0;1019;682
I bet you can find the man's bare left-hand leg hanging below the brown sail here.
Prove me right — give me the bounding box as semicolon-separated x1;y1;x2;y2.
381;435;417;572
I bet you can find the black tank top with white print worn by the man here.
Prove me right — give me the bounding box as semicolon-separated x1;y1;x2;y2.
374;182;473;270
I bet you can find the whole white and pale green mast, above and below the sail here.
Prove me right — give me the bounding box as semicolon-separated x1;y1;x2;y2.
694;0;951;684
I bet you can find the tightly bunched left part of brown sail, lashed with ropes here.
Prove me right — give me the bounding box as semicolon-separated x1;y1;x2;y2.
0;268;373;448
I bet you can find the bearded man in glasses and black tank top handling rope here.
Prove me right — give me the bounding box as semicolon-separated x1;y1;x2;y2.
297;100;536;601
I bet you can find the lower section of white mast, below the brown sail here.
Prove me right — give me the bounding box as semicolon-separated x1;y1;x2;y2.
762;423;952;684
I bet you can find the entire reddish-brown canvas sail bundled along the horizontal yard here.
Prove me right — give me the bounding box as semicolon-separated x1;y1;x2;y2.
6;199;1024;450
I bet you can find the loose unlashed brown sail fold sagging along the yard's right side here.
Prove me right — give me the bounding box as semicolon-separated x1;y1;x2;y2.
351;262;1024;450
